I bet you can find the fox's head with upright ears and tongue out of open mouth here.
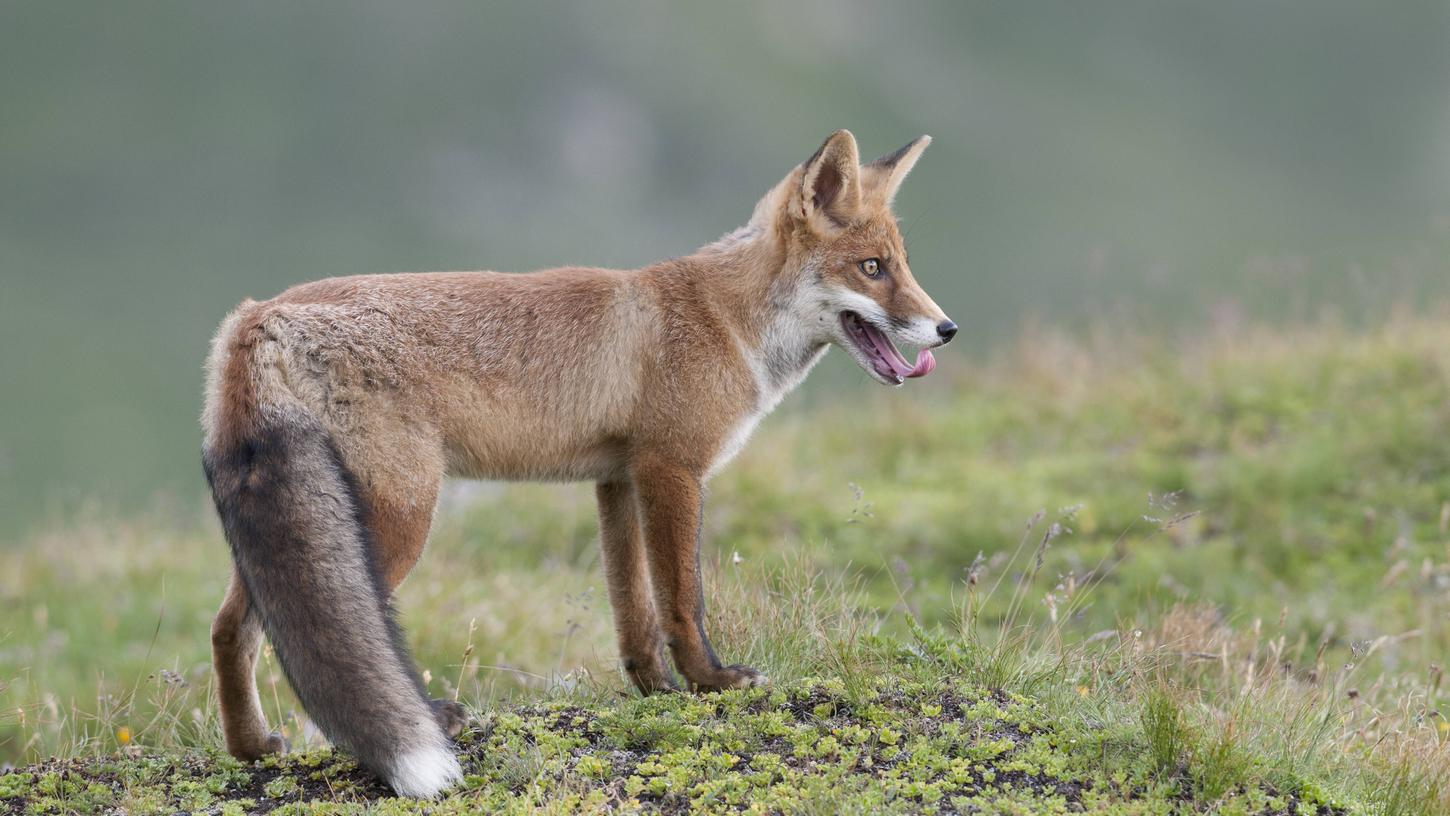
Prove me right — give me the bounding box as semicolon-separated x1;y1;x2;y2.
753;130;957;386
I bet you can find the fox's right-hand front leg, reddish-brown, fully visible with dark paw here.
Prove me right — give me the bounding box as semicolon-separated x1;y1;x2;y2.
634;461;766;691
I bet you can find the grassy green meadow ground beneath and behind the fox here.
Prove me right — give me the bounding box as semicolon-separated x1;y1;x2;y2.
0;319;1450;815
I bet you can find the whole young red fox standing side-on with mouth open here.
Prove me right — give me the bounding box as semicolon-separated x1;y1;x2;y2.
202;130;957;799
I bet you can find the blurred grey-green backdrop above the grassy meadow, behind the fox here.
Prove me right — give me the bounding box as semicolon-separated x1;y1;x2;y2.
0;0;1450;541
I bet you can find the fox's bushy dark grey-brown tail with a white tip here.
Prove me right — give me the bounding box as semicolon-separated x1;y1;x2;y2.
204;404;463;797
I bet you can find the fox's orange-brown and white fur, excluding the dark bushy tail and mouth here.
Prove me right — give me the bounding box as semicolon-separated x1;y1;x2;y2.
204;130;954;782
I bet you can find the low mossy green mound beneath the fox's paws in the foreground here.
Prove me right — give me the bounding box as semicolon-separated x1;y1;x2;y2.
0;672;1343;816
